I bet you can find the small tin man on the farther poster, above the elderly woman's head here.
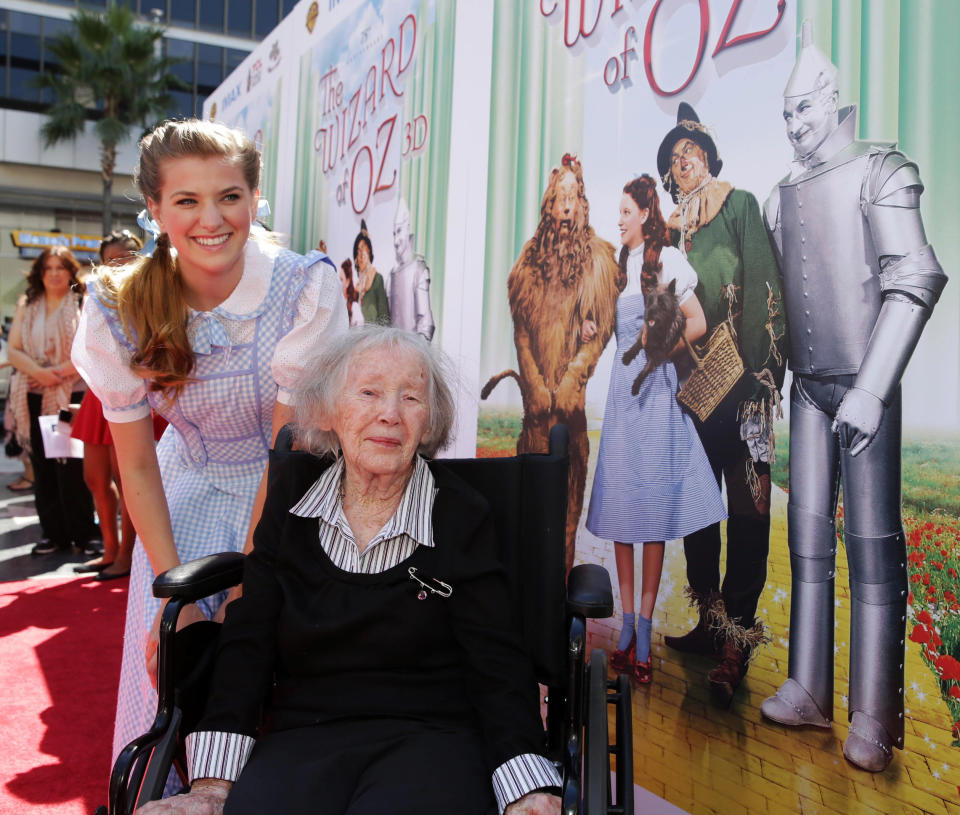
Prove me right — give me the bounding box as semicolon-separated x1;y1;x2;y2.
387;198;435;342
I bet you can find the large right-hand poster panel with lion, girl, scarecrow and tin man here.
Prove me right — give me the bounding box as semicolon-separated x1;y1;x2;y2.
477;0;960;813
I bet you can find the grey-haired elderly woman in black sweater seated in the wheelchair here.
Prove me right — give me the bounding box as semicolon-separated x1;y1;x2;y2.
138;326;561;815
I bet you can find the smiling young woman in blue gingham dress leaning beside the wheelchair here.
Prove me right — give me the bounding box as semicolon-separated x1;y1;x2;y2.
72;120;346;768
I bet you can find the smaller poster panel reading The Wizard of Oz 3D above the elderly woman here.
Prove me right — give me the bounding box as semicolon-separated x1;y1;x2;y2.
291;0;456;338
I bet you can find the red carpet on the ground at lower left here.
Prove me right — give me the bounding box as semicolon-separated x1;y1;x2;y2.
0;578;128;815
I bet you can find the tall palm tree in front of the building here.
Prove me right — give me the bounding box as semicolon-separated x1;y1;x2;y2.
36;5;185;235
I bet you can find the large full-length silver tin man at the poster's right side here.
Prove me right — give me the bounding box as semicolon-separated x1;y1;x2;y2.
761;21;947;772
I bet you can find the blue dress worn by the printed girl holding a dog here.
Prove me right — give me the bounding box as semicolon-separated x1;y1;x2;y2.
586;278;727;544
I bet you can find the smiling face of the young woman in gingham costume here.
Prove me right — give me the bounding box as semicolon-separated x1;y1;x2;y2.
148;156;259;287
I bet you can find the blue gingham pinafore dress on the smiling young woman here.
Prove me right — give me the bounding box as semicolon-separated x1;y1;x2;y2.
79;245;340;768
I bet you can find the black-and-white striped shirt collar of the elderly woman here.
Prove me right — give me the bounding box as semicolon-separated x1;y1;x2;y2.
290;456;436;547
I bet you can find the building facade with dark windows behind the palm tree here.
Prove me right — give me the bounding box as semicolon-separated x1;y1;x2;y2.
0;0;286;317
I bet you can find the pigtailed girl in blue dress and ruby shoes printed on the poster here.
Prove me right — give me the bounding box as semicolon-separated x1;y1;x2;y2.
586;175;726;684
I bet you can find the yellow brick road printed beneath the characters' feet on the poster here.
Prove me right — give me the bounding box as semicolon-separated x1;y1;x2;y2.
577;462;960;815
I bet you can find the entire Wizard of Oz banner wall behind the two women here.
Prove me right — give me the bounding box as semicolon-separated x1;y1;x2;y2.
204;0;960;814
